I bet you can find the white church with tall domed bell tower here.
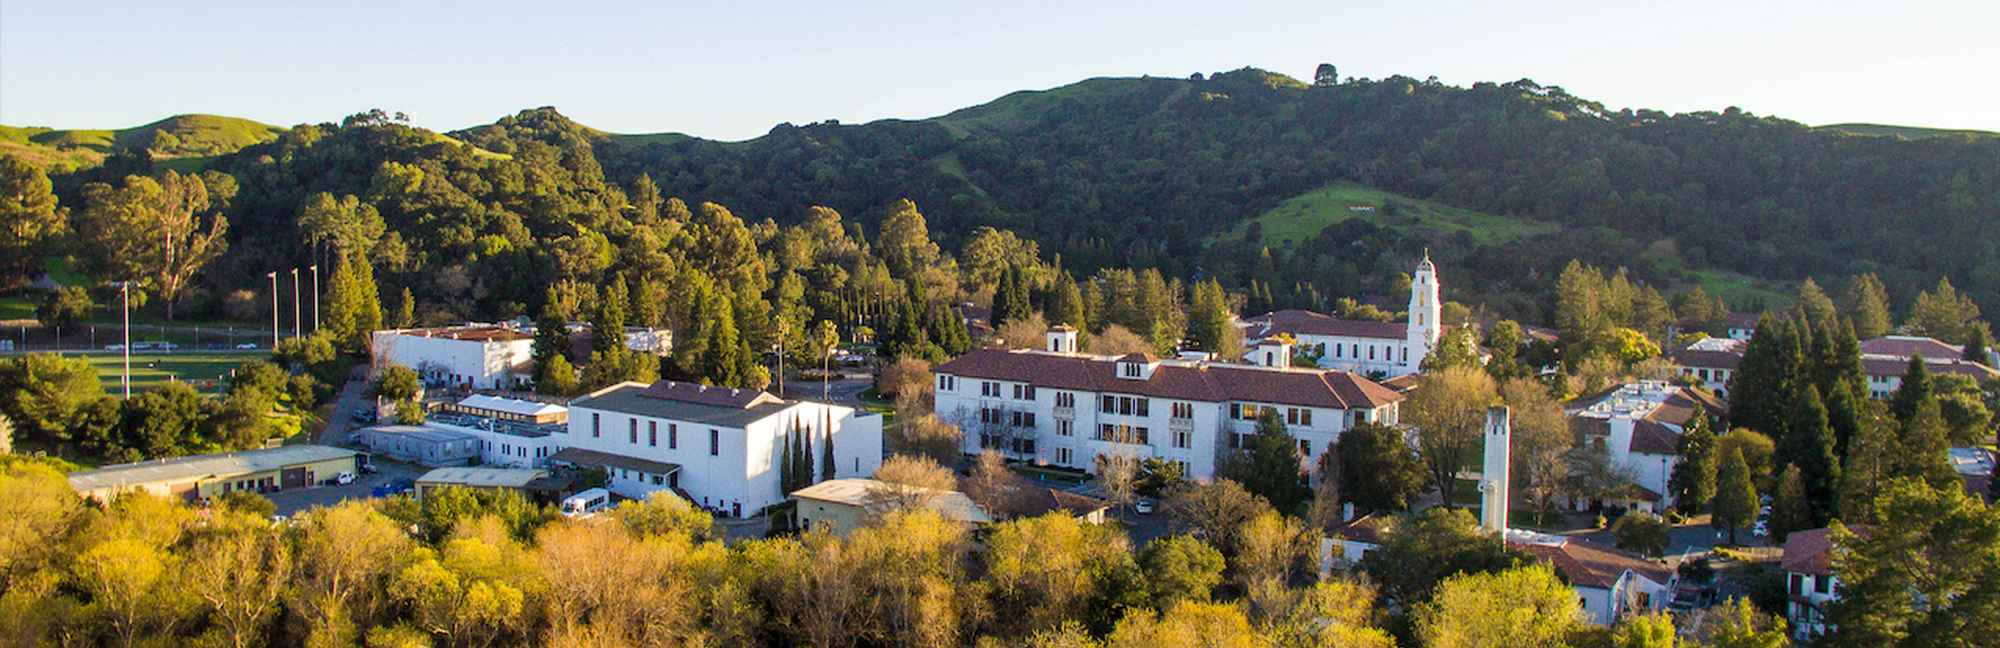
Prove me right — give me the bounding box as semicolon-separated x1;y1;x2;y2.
1244;254;1444;378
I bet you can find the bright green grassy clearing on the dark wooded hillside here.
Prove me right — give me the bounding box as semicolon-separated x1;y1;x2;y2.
1236;182;1560;244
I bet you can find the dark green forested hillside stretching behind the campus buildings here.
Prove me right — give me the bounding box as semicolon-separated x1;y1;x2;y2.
8;68;2000;320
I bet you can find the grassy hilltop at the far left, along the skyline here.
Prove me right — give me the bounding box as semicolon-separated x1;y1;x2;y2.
0;114;284;170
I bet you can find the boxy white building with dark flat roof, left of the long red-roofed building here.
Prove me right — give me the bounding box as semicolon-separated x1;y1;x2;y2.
550;380;882;518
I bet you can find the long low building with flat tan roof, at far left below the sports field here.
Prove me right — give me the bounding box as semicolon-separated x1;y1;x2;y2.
70;446;360;502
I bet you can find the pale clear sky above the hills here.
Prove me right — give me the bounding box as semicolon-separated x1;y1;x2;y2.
0;0;2000;140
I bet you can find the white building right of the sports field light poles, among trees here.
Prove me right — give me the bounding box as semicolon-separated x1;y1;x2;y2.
368;324;534;390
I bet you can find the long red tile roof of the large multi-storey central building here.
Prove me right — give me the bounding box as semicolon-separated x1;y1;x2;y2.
934;348;1404;410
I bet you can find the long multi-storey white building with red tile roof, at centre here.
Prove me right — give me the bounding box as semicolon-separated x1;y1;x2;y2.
932;326;1402;480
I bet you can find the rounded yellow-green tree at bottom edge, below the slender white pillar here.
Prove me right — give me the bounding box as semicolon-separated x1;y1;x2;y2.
1416;564;1584;648
